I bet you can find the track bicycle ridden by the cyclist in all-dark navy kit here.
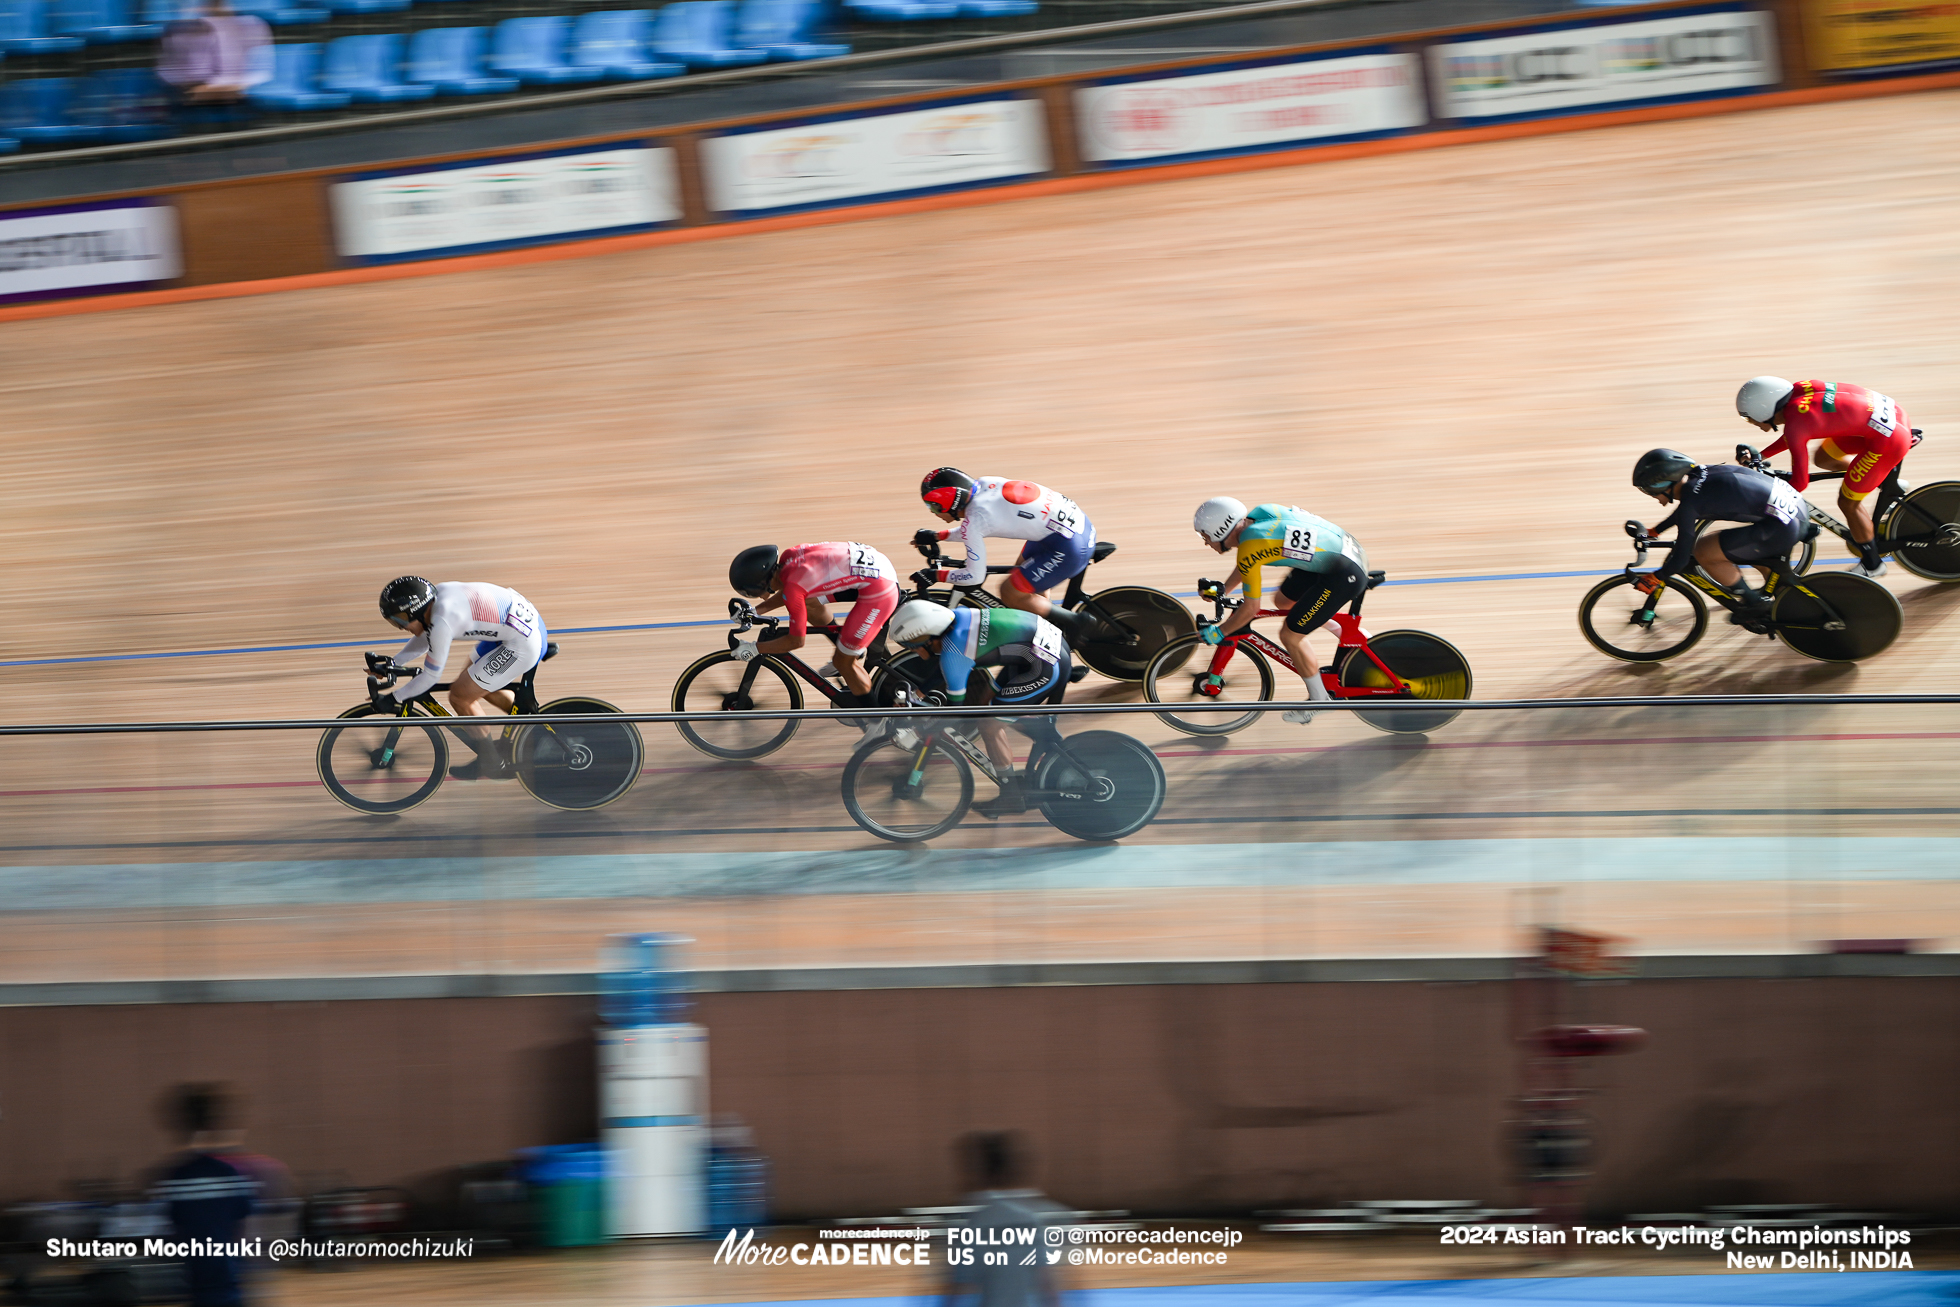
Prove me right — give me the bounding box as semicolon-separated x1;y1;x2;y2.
1580;521;1905;662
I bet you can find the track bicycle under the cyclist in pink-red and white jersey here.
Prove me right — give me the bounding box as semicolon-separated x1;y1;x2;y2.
674;598;923;760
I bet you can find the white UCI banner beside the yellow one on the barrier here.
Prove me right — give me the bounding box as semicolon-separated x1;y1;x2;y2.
1429;10;1780;120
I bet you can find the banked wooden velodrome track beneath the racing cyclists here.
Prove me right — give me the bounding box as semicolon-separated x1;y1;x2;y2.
0;92;1960;980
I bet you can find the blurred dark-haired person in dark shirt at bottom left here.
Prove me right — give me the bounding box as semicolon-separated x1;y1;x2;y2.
151;1084;292;1307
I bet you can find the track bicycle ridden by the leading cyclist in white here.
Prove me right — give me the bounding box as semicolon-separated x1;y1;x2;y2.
316;643;645;813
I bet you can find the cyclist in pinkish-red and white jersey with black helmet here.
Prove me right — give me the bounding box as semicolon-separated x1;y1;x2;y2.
729;541;898;705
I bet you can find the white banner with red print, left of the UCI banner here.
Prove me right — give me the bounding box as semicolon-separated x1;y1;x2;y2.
1076;51;1429;167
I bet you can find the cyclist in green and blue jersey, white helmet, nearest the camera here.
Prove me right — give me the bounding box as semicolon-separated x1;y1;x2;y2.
892;600;1070;817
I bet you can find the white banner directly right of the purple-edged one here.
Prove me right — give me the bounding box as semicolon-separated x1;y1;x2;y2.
333;145;680;263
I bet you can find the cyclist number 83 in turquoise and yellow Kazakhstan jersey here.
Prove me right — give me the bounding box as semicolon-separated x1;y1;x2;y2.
1192;496;1368;725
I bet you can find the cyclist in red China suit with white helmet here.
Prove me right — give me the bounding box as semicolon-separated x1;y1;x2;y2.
1735;376;1913;576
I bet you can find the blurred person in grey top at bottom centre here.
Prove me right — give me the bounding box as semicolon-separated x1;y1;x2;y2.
939;1131;1068;1307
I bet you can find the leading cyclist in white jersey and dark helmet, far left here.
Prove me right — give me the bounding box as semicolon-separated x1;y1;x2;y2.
380;576;545;780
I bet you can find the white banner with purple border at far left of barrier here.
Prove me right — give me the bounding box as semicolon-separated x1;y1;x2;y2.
0;200;184;304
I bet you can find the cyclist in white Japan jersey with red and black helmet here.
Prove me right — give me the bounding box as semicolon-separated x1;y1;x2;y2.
911;468;1096;641
